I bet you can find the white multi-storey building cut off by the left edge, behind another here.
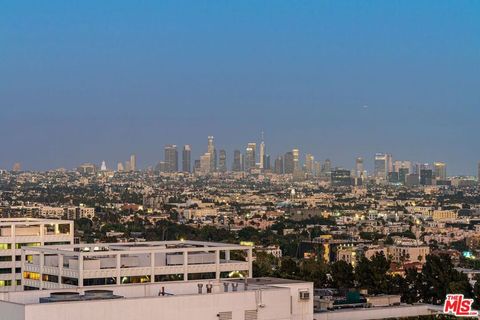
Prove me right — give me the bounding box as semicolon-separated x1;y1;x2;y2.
0;218;74;291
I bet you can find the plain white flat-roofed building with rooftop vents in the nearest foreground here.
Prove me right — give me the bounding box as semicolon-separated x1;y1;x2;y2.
0;278;313;320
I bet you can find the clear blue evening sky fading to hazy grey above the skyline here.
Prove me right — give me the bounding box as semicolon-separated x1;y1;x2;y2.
0;0;480;174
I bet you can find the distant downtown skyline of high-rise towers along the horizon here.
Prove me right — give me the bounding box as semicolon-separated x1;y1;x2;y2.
0;131;480;177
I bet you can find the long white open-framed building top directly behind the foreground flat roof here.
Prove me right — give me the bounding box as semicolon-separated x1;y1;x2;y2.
21;241;252;290
